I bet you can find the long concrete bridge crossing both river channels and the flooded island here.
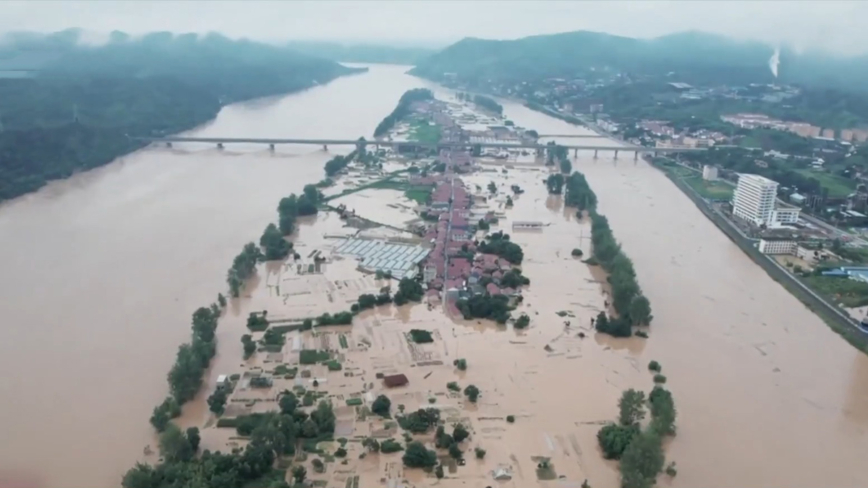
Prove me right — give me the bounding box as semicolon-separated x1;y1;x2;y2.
133;136;705;159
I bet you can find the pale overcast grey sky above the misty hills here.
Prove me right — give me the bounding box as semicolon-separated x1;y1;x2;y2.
0;0;868;54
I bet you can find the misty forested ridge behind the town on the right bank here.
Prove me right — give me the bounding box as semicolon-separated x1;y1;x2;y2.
411;31;868;88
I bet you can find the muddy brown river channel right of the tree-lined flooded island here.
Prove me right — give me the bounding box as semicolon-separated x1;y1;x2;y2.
496;103;868;487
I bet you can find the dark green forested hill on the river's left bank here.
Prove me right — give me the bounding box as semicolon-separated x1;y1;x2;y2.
0;31;357;200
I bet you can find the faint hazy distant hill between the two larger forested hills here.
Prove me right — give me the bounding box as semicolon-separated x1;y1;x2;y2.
288;41;435;64
